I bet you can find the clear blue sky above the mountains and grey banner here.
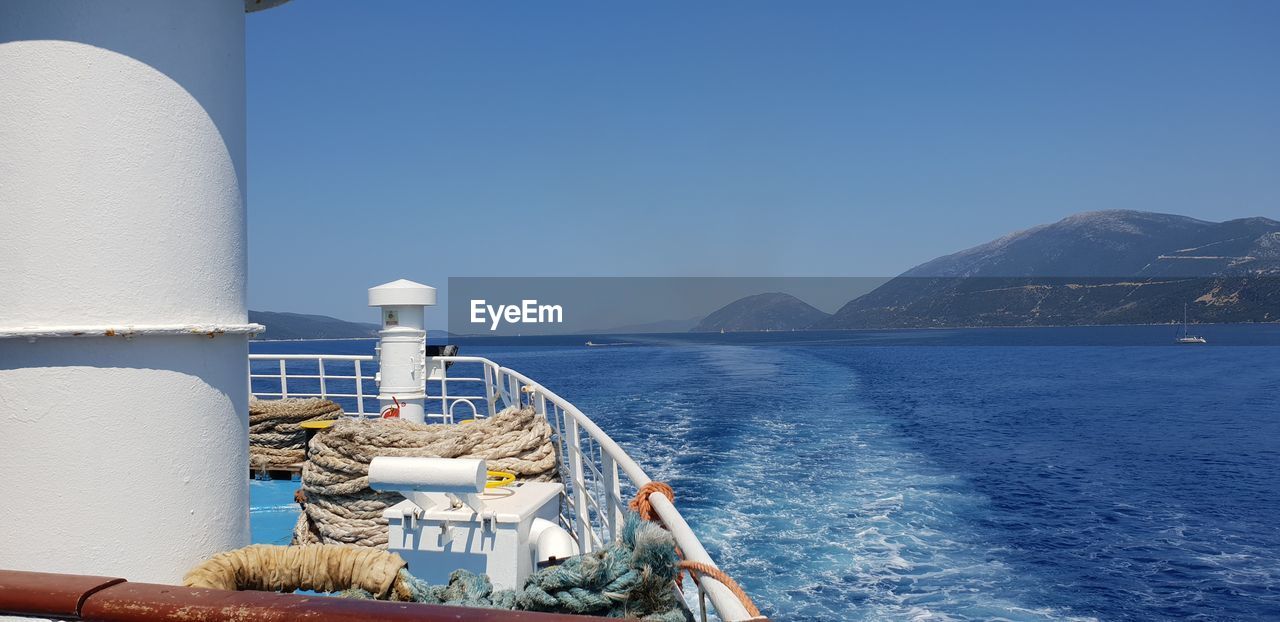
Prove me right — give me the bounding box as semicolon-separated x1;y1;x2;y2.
248;0;1280;321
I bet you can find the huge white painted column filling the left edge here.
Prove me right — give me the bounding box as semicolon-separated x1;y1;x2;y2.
0;0;262;582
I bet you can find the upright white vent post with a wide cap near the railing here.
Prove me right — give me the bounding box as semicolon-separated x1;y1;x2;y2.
369;279;435;424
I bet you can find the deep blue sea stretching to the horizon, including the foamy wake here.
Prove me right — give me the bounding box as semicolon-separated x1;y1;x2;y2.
252;326;1280;621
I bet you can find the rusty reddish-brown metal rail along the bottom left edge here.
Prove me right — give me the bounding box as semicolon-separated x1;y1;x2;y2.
0;570;605;622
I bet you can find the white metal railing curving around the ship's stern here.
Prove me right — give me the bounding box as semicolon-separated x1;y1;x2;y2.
250;355;751;621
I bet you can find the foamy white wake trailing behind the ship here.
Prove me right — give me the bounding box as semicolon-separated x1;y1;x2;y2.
589;346;1078;621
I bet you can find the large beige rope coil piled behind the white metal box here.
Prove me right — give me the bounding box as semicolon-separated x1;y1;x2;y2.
293;407;559;548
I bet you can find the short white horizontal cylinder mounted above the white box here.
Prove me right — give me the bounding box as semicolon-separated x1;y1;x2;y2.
369;456;489;494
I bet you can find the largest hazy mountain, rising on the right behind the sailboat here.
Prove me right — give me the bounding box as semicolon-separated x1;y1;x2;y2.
813;211;1280;329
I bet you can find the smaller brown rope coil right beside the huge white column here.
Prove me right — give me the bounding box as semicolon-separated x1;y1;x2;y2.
248;398;342;470
